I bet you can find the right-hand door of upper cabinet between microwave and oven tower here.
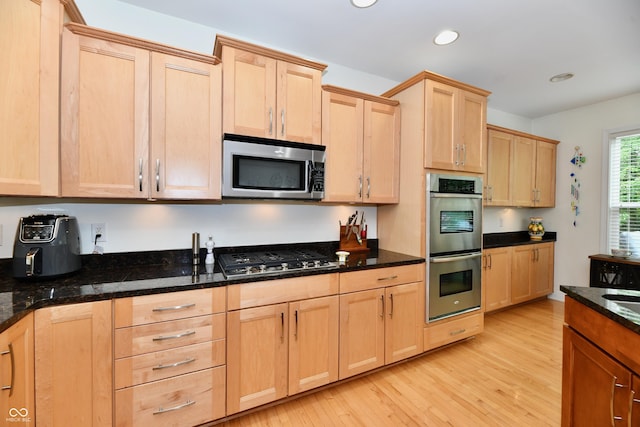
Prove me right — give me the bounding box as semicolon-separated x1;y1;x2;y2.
363;101;400;203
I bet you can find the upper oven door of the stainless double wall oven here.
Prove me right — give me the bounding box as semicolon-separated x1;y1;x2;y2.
428;193;482;256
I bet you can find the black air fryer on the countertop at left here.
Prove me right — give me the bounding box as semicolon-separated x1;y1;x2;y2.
13;215;81;278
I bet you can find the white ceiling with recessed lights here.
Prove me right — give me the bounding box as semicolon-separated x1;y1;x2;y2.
116;0;640;119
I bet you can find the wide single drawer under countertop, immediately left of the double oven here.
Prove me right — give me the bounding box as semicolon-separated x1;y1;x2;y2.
340;264;424;294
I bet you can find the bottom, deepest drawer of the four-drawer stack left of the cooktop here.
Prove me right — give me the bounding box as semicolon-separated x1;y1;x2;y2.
115;366;226;427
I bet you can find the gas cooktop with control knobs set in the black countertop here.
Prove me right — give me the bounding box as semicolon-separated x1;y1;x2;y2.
218;249;338;279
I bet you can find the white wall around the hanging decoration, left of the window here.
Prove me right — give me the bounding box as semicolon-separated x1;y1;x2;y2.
533;93;640;297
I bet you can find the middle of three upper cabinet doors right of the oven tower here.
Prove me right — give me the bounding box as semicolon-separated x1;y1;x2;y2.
511;136;536;206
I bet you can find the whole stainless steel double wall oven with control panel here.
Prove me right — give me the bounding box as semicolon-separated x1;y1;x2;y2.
427;174;482;322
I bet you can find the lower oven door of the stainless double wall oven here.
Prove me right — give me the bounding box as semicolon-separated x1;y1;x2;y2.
427;252;482;322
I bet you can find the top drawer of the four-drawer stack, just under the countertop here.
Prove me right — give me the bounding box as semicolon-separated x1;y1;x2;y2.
115;287;226;328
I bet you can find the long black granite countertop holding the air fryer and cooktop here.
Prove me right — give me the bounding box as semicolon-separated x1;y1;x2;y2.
0;242;424;332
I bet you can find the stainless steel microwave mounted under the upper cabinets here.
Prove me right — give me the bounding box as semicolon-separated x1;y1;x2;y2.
222;134;326;200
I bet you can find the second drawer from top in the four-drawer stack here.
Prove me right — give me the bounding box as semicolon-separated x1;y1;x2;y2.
114;314;226;359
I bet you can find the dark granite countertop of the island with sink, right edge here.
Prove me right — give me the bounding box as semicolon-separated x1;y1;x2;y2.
560;286;640;334
